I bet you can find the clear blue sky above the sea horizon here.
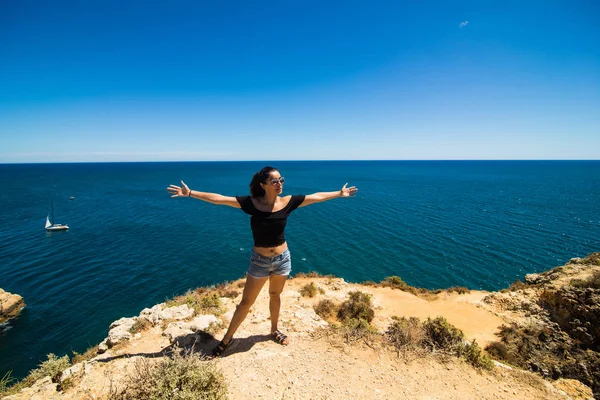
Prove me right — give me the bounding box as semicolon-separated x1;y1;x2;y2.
0;0;600;163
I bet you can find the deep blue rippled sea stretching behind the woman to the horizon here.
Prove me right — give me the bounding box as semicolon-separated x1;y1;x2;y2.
0;161;600;378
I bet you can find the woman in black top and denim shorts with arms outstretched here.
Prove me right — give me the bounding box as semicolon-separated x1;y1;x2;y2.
168;167;358;357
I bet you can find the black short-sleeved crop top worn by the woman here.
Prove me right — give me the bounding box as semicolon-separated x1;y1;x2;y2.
235;195;305;247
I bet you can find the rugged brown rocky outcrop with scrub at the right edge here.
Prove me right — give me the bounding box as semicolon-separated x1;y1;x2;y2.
484;253;600;398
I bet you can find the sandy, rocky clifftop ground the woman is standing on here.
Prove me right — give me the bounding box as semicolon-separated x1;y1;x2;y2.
6;258;600;400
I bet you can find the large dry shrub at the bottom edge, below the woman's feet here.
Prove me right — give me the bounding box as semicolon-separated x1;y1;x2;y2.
110;352;227;400
